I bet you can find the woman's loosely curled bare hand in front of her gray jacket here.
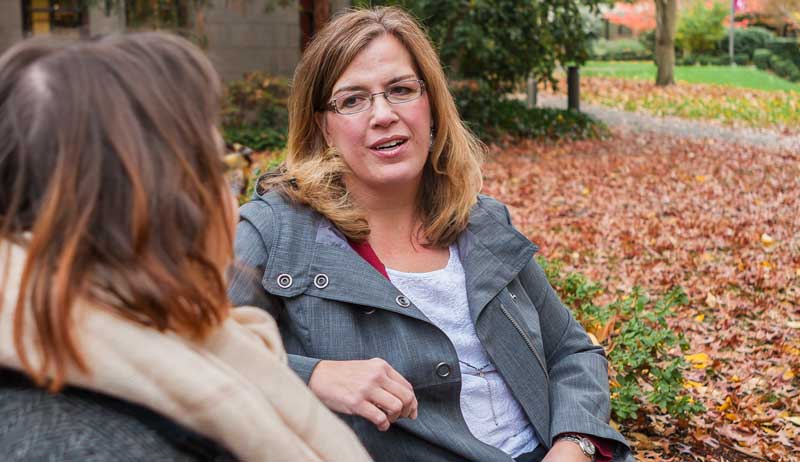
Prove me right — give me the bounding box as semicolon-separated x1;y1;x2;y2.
308;358;417;431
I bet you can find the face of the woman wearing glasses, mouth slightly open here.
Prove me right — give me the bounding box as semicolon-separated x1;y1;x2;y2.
322;34;431;199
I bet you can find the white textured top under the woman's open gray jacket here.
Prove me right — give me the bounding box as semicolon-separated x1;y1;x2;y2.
386;245;539;457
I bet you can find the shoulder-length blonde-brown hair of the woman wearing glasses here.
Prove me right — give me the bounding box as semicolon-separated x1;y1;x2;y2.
266;7;485;246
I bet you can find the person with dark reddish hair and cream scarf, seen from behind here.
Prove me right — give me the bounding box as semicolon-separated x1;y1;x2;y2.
0;33;370;462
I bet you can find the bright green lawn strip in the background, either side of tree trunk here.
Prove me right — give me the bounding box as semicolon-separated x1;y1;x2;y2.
581;61;800;91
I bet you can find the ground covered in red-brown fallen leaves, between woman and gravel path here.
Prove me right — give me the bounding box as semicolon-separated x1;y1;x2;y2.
484;133;800;462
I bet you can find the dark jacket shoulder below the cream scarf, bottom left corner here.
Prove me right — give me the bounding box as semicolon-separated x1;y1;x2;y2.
0;369;234;462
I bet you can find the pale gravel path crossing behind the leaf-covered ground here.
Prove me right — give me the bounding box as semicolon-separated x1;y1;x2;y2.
538;93;800;150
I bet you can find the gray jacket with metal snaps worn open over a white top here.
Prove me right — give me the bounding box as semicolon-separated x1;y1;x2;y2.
229;192;633;462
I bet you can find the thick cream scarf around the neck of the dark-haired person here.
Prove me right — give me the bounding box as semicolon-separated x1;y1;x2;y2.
0;242;371;462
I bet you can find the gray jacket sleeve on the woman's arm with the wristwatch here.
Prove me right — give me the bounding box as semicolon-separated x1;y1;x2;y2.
505;204;633;462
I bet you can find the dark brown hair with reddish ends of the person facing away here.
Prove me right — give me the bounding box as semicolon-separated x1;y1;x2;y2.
0;33;233;390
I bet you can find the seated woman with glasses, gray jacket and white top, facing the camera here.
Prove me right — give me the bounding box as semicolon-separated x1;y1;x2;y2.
229;8;630;462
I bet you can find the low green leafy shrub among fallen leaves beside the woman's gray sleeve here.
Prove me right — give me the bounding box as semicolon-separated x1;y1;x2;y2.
538;257;705;422
